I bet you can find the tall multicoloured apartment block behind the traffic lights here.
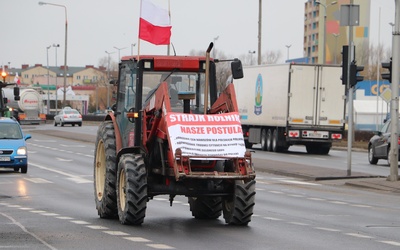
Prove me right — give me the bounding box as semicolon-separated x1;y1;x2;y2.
303;0;371;65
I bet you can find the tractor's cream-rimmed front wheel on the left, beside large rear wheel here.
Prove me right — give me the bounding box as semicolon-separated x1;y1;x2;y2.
117;154;148;225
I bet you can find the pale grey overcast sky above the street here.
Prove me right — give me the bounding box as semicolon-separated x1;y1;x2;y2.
0;0;395;68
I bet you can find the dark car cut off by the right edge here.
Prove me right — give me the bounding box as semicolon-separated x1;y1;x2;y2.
368;119;400;165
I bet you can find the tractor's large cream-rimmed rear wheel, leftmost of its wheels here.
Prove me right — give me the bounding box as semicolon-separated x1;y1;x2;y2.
93;121;118;218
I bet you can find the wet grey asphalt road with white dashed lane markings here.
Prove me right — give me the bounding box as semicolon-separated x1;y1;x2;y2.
0;126;400;250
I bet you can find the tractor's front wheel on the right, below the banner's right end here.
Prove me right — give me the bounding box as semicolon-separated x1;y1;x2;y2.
222;180;256;226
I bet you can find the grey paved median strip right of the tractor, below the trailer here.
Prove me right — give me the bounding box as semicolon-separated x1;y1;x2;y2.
253;158;400;193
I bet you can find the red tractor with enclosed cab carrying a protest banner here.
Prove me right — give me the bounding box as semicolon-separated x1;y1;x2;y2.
94;44;255;225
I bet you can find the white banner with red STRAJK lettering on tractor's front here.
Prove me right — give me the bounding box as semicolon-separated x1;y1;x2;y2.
166;112;246;157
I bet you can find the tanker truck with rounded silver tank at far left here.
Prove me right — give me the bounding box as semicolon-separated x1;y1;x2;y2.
3;88;46;124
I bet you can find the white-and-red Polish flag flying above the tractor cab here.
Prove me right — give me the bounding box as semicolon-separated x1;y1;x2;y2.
139;0;172;45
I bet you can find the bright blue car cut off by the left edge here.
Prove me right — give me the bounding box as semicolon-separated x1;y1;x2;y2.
0;117;31;174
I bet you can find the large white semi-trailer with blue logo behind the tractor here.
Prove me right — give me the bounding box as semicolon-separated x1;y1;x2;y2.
233;64;346;154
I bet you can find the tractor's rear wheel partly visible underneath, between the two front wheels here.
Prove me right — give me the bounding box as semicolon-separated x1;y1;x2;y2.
188;196;222;219
